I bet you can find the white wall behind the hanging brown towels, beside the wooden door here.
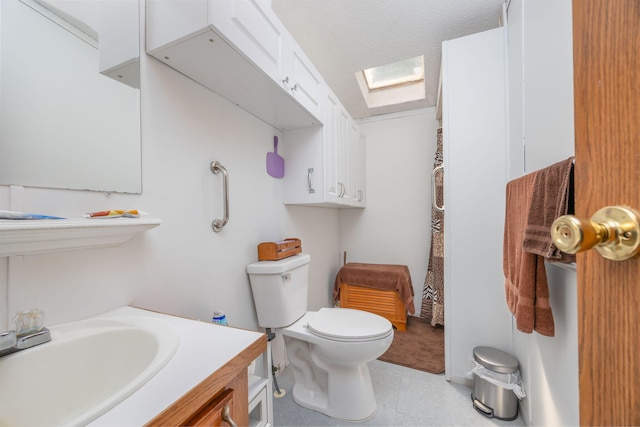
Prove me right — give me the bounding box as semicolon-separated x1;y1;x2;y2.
508;0;579;425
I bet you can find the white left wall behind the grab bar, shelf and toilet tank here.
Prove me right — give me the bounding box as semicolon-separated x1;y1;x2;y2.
0;4;340;338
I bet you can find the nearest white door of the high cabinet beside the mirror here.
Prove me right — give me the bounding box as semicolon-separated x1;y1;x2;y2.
209;0;287;81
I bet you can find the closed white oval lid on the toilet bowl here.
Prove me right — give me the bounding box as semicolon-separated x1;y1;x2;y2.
307;308;393;341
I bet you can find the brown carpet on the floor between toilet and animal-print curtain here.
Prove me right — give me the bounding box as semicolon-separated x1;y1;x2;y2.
378;316;444;374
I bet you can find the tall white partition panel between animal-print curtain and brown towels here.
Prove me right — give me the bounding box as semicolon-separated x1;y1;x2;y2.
442;28;512;384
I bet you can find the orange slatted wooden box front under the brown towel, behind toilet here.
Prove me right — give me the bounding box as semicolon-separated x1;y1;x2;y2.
340;283;407;331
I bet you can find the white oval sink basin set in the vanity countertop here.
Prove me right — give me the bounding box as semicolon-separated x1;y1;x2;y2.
0;316;180;426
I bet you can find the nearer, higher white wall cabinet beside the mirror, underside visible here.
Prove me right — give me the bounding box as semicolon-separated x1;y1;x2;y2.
146;0;324;130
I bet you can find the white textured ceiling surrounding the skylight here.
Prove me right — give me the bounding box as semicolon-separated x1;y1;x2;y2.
272;0;504;118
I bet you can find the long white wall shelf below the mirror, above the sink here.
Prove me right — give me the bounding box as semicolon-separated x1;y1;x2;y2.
0;218;162;257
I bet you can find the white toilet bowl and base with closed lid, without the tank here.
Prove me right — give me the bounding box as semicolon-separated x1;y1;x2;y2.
277;308;393;421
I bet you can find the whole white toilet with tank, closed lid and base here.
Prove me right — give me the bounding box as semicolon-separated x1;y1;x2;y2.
247;253;393;421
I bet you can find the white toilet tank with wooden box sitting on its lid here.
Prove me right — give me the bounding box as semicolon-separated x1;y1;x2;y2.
247;253;311;328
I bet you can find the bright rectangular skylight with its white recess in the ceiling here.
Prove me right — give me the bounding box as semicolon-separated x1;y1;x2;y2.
356;56;426;108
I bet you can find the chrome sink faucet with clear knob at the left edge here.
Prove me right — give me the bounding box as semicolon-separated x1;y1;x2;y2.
0;310;51;357
